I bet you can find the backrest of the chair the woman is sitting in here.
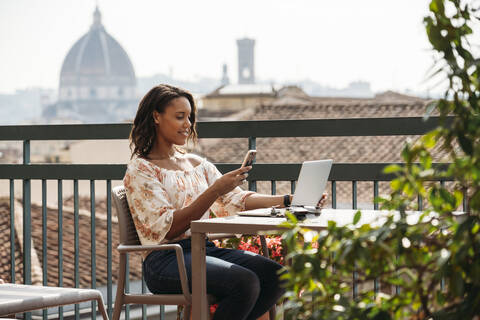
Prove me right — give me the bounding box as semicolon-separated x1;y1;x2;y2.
112;185;140;245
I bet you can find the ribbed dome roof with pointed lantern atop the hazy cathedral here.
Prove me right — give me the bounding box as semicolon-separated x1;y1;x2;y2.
60;7;135;86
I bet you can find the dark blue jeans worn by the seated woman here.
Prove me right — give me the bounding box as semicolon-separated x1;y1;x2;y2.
143;239;284;320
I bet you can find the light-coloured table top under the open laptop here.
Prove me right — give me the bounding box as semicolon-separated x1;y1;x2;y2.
190;209;412;234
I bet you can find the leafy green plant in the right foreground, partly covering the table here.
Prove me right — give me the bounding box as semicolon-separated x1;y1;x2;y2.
283;0;480;319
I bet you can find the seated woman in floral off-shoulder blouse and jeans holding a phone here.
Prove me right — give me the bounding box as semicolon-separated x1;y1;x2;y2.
124;85;326;320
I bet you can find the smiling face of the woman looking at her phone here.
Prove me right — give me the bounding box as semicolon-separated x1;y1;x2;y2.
153;97;192;145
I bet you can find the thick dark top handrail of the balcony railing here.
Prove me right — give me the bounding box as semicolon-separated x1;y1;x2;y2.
0;117;451;141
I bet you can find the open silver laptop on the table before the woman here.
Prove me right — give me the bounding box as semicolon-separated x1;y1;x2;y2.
238;159;333;217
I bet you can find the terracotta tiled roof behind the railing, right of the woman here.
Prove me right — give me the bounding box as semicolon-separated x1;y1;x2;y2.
199;98;446;207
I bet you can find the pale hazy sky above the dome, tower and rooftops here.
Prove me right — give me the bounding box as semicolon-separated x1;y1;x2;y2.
0;0;438;93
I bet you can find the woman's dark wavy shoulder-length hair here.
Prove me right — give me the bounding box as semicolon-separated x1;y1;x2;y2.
130;84;197;158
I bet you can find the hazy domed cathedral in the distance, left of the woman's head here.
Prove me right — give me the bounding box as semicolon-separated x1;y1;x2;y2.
44;7;138;122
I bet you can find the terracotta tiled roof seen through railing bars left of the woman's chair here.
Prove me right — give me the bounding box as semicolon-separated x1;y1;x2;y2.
0;199;141;288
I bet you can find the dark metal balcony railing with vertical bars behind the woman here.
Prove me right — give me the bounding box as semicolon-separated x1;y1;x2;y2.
0;117;454;320
